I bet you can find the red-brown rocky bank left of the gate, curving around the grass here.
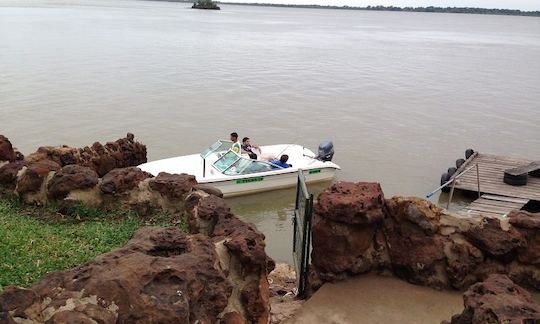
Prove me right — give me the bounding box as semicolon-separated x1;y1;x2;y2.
0;134;274;323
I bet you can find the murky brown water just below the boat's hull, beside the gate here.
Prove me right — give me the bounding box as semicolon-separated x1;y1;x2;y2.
226;181;333;264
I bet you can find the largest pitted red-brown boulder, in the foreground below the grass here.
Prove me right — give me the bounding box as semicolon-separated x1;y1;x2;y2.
0;227;232;323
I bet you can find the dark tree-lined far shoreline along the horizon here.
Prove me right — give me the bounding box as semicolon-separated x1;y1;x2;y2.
159;0;540;17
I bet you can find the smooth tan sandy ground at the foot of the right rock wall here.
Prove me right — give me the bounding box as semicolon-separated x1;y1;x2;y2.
285;275;463;324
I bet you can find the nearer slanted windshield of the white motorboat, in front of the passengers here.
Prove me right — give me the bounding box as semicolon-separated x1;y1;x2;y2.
212;150;284;176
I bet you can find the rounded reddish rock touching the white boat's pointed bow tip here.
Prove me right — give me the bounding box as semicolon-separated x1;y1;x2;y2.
100;167;152;194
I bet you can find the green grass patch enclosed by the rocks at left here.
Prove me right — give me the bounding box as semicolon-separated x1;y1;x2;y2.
0;199;187;291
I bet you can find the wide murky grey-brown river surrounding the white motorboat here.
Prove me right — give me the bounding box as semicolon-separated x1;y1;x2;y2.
0;0;540;262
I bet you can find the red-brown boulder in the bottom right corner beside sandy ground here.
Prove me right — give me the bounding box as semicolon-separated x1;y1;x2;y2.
443;274;540;324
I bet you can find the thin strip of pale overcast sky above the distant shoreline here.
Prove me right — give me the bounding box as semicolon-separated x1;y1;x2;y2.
230;0;540;10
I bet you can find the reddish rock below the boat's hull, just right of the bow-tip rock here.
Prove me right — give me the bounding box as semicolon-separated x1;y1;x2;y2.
150;172;197;198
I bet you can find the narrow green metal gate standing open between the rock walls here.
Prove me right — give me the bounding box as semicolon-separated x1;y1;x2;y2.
293;170;313;297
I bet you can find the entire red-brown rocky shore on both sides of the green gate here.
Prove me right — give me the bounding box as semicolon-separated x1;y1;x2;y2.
0;134;540;324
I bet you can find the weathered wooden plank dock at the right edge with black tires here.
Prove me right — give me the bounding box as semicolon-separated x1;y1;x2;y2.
452;152;540;218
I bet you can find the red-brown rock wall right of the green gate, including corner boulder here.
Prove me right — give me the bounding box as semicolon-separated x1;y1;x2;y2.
310;182;540;323
